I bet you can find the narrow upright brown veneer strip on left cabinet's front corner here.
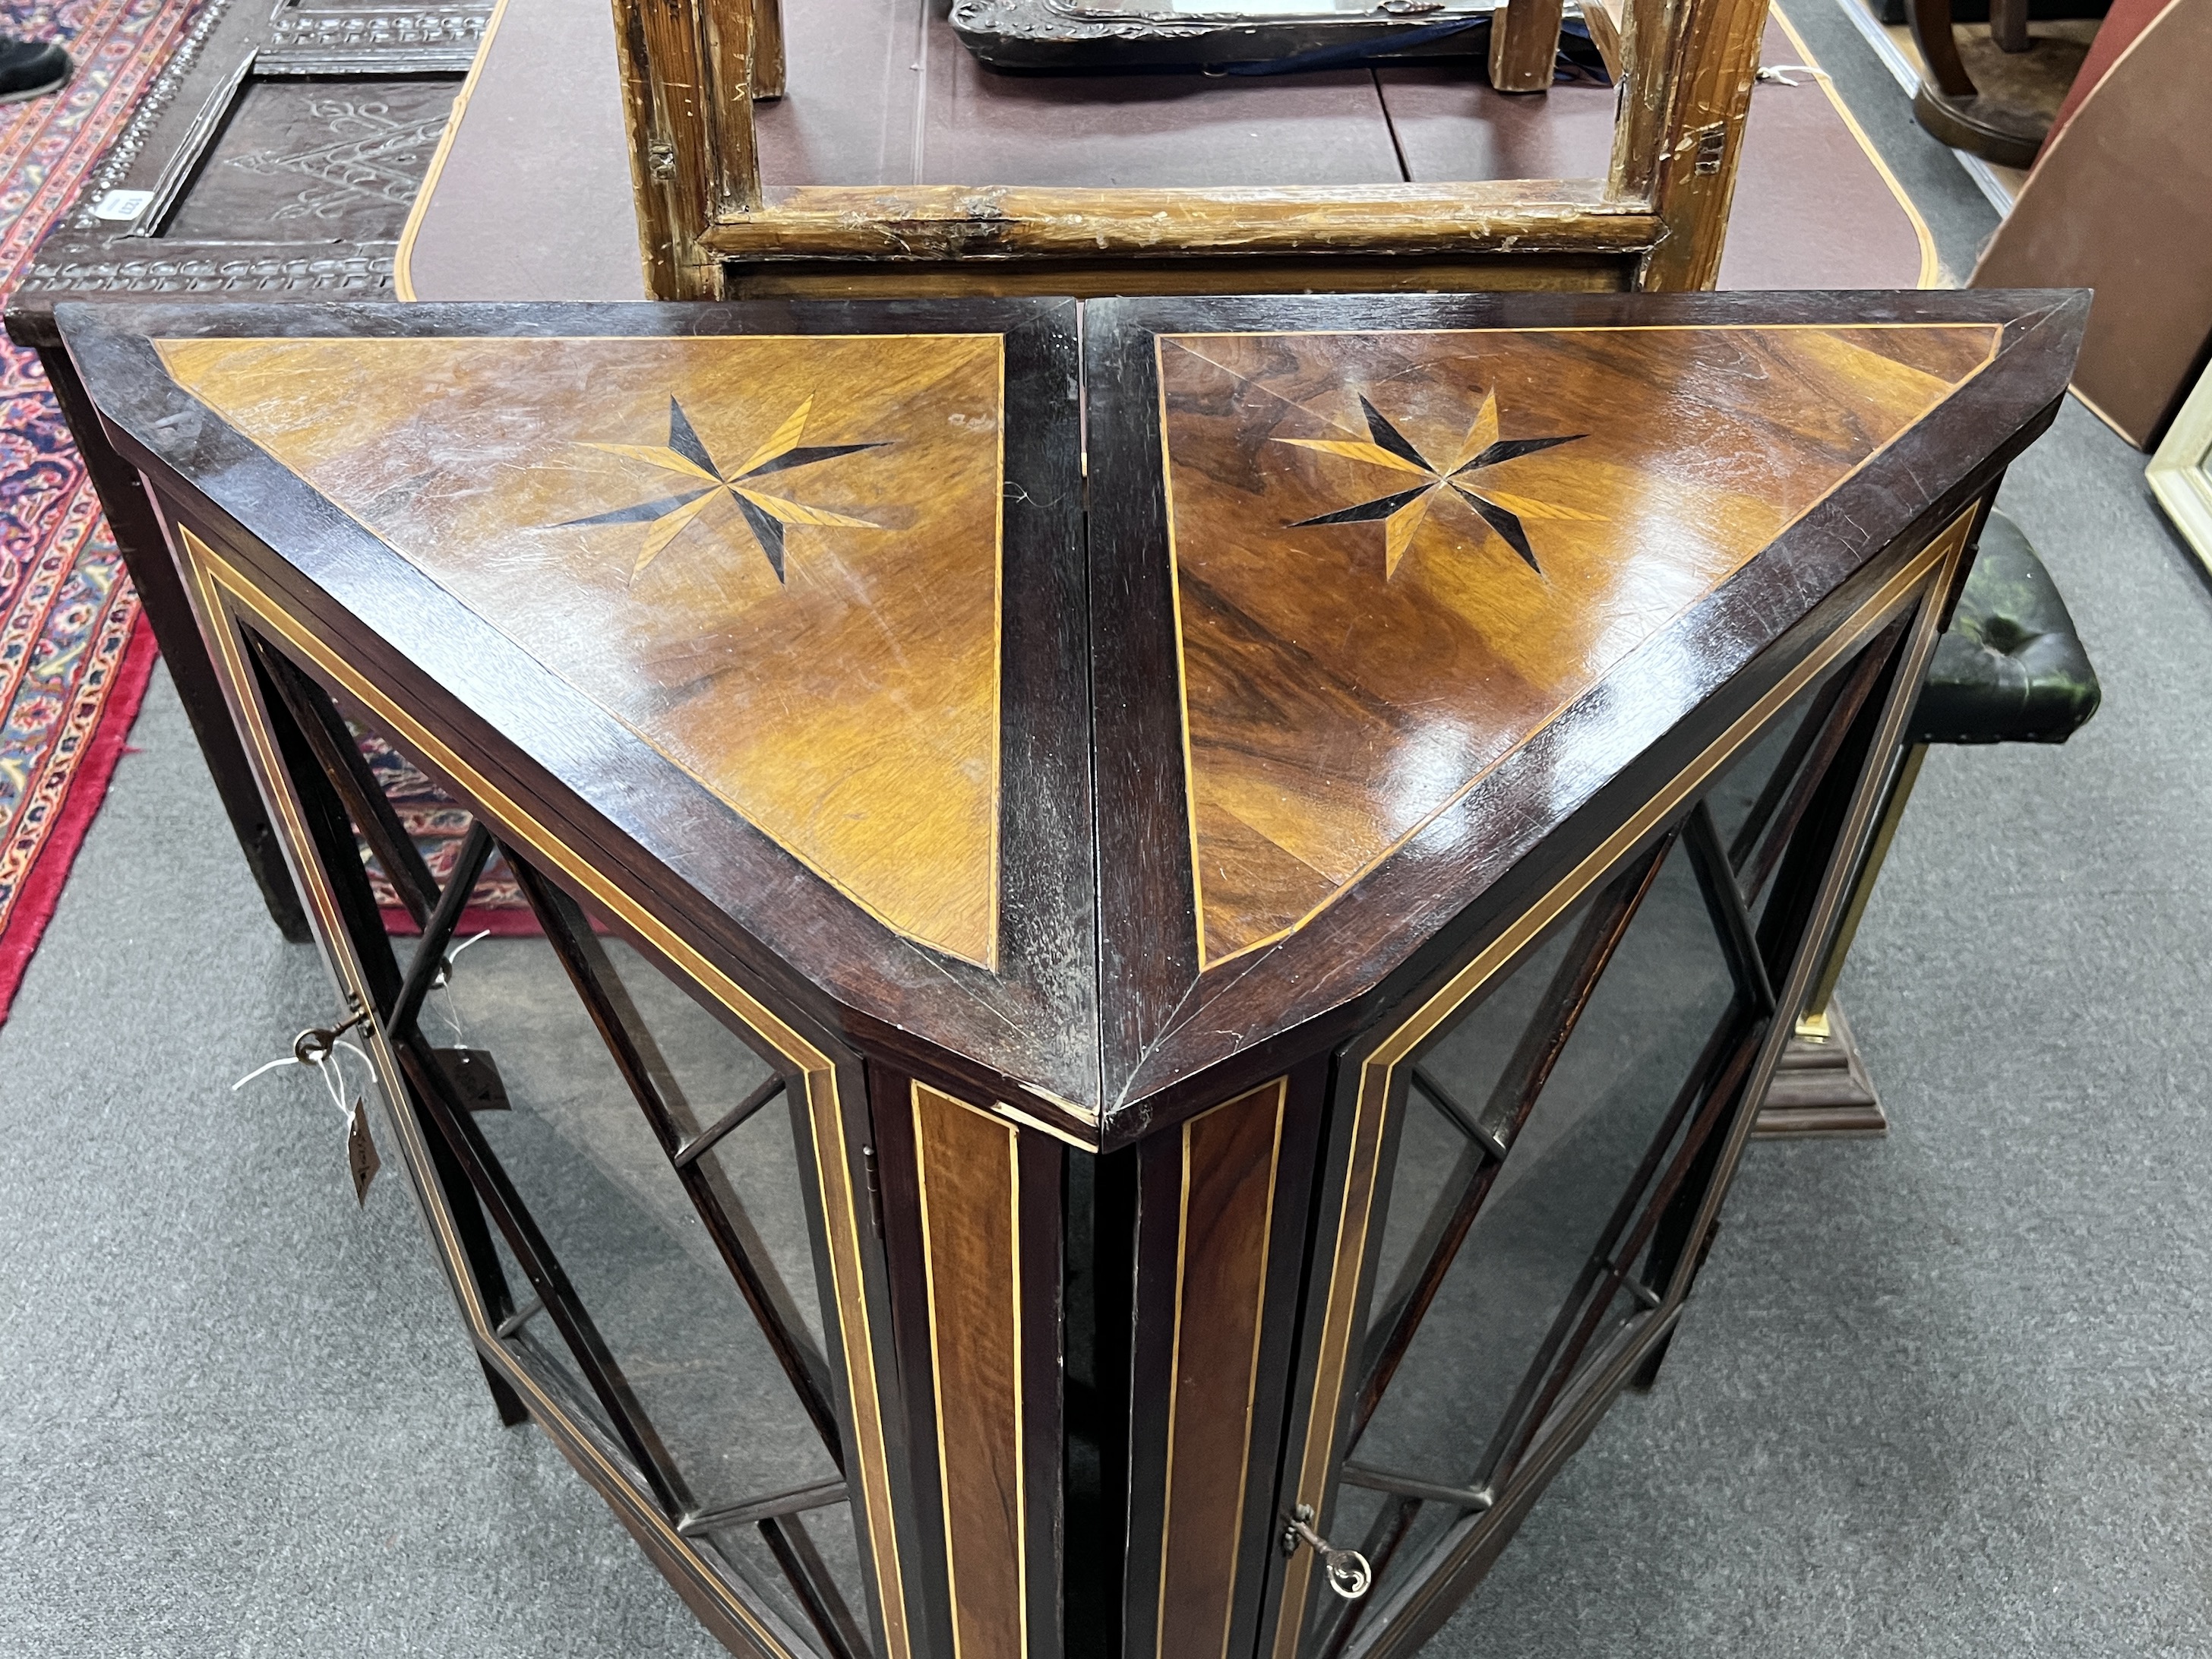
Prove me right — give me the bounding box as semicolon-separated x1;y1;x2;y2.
914;1084;1029;1659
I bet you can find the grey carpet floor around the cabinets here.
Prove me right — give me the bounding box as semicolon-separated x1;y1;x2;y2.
0;0;2212;1659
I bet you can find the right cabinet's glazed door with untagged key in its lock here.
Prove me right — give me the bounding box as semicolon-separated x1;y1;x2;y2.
1266;509;1975;1659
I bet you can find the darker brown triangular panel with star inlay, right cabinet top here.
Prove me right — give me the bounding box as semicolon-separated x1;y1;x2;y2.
1157;323;1999;965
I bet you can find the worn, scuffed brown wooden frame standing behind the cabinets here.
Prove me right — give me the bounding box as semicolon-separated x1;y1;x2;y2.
615;0;1768;299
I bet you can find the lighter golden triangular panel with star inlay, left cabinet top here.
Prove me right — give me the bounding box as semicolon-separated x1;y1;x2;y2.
160;334;1004;967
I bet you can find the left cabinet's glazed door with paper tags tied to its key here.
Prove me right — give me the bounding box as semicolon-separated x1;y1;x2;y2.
160;502;907;1659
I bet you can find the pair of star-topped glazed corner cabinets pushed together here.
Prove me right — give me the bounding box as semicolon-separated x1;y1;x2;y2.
60;292;2086;1659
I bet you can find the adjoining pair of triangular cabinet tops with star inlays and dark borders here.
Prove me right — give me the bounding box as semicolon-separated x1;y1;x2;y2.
62;292;2086;1142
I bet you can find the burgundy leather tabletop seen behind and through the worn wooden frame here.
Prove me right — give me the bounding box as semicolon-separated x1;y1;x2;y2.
398;0;1938;301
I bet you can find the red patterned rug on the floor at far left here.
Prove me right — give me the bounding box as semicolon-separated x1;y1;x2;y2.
0;0;194;1019
